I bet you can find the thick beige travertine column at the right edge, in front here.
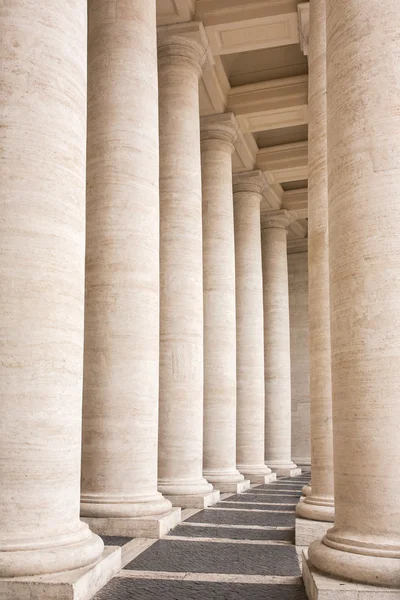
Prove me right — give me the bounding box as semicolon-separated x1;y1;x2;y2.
309;0;400;598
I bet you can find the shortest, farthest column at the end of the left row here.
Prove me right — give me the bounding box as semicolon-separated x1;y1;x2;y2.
261;210;301;477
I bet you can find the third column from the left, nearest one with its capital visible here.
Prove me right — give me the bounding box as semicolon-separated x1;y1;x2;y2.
158;23;218;508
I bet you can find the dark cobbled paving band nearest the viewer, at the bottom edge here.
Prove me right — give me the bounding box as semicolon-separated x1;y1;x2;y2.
93;577;307;600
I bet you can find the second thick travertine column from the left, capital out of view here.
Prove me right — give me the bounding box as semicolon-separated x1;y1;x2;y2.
81;0;175;536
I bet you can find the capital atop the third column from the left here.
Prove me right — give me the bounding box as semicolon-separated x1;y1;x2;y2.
157;21;212;76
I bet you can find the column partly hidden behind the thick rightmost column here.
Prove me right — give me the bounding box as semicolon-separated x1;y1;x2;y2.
296;0;334;533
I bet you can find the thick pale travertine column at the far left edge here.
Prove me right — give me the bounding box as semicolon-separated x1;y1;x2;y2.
0;0;103;576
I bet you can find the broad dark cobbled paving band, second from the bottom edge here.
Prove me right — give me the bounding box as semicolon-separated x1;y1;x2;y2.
124;540;300;576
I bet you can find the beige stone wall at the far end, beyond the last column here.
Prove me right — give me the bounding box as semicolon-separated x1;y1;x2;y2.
288;252;311;464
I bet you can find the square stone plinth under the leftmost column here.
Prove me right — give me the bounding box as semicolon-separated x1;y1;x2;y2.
0;546;121;600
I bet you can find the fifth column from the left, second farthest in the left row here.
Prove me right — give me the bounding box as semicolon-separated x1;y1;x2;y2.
233;171;276;483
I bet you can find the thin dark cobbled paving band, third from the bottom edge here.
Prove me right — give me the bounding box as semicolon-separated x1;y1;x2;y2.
169;525;295;544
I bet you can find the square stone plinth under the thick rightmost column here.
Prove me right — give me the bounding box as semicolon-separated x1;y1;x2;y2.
302;550;400;600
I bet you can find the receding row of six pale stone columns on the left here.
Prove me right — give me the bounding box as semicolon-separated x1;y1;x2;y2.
0;0;295;577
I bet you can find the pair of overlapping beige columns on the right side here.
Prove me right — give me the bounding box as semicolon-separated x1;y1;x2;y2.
296;0;400;598
